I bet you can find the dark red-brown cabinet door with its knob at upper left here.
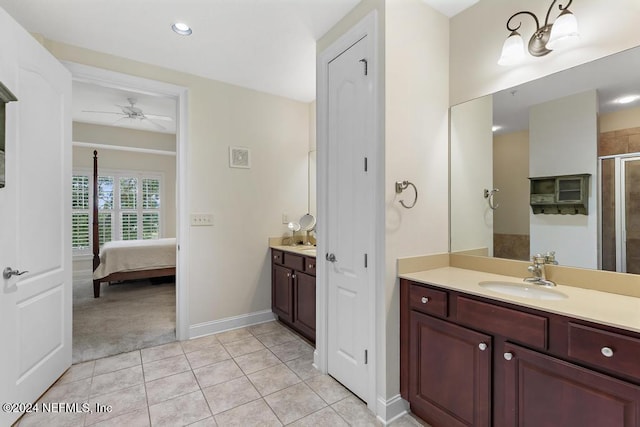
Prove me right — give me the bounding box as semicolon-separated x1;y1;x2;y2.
496;343;640;427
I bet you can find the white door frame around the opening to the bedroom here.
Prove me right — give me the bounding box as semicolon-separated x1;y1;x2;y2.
61;61;189;341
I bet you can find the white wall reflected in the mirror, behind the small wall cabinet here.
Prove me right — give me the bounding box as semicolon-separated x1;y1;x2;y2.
529;90;598;268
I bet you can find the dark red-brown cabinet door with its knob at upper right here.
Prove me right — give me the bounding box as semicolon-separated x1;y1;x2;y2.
409;311;492;427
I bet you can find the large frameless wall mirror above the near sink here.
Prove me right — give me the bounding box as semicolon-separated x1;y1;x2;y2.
450;47;640;273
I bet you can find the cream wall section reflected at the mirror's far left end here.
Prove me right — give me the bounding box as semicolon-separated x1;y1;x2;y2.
450;96;501;255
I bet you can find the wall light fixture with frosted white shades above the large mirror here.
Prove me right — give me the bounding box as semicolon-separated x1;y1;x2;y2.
498;0;579;65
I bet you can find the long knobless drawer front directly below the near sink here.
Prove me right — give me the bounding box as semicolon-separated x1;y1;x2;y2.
456;296;548;349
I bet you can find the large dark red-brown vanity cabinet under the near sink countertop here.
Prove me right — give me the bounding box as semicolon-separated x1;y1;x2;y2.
400;279;640;427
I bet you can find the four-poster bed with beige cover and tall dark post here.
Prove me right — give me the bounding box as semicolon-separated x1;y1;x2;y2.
92;151;176;298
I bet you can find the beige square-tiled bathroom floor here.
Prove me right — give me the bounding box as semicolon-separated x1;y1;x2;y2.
18;322;425;427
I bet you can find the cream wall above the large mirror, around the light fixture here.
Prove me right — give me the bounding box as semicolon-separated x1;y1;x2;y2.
450;0;640;105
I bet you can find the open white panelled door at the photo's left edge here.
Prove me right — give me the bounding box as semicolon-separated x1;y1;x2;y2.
0;9;71;425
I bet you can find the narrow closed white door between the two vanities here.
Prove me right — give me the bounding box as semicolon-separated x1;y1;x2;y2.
325;36;374;401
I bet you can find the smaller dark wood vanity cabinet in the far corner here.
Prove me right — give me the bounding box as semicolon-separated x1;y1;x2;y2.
271;249;316;342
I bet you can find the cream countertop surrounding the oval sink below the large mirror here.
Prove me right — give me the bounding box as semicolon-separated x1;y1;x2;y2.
399;267;640;333
